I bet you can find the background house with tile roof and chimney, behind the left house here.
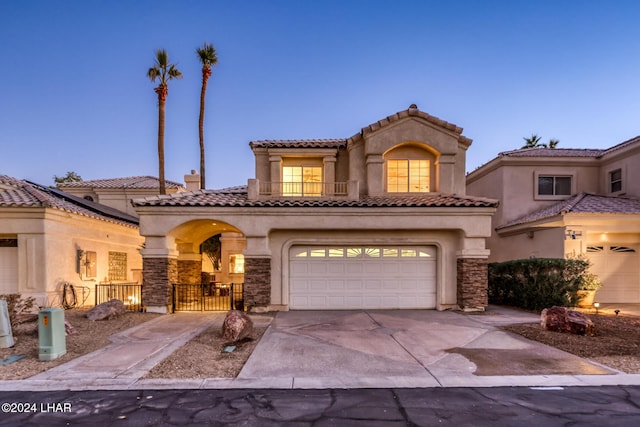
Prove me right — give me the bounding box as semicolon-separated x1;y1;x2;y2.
57;176;188;216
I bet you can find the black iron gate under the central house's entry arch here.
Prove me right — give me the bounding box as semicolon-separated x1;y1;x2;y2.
172;283;244;312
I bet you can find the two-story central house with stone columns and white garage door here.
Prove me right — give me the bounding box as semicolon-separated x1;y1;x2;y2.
133;106;497;312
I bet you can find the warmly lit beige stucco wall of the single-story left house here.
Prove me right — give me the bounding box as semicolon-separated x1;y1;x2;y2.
0;209;144;306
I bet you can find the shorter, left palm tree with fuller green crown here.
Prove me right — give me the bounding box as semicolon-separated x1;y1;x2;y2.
147;49;182;194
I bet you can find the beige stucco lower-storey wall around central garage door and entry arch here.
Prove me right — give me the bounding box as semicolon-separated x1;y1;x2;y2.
138;207;494;309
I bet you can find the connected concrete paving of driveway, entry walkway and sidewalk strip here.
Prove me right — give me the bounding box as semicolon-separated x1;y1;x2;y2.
0;307;640;391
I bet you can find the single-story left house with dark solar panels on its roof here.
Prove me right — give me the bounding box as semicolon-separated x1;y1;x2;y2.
0;175;144;306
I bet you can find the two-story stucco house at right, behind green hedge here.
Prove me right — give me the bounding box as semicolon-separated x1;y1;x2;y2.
467;137;640;303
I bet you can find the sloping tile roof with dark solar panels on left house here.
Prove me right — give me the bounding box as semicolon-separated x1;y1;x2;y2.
0;175;139;226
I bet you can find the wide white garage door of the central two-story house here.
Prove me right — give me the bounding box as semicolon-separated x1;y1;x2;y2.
289;245;436;310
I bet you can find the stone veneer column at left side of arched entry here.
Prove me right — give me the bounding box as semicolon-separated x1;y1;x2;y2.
142;258;178;313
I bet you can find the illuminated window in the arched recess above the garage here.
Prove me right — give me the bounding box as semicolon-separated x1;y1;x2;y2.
387;160;430;193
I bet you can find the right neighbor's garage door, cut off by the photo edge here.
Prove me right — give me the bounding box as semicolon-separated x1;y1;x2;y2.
587;244;640;303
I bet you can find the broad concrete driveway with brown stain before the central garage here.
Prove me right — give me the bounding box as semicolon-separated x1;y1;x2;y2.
238;308;614;388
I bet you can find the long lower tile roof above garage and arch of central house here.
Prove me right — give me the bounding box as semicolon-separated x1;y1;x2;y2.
133;187;498;208
